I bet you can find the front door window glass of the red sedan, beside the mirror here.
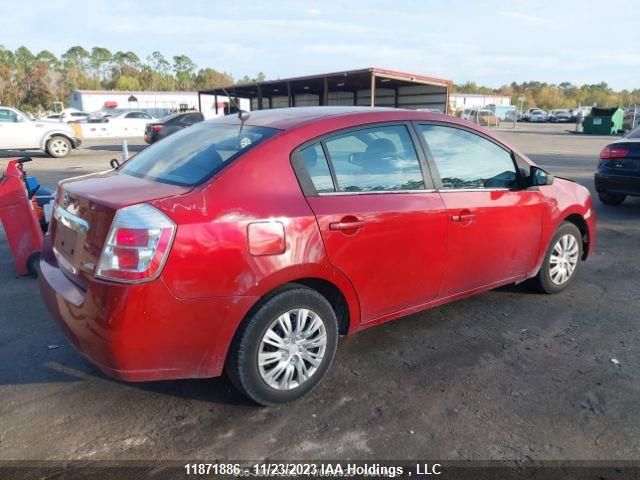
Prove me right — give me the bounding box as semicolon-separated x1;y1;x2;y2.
420;125;518;190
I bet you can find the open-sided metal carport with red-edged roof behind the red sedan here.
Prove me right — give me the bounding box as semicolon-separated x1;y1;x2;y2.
198;67;452;117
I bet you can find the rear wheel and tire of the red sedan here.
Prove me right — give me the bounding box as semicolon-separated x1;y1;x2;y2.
226;287;338;405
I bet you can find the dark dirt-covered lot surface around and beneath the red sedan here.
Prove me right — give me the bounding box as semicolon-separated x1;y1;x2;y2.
0;125;640;460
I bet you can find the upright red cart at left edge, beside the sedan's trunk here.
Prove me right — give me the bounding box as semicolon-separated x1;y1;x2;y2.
0;157;43;275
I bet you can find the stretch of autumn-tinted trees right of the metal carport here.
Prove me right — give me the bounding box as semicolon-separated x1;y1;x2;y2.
452;82;640;110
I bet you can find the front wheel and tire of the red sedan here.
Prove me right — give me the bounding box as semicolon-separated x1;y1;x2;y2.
532;222;583;294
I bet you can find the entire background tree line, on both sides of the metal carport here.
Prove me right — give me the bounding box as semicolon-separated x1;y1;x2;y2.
0;45;640;112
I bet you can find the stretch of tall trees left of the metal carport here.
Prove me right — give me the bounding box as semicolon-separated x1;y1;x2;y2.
0;45;264;112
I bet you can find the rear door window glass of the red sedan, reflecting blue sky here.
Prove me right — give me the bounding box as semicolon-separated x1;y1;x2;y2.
325;125;425;192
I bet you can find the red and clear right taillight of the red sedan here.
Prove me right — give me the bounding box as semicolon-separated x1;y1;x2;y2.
96;203;176;282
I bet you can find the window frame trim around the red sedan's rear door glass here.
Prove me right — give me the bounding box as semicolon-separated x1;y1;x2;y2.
290;120;436;197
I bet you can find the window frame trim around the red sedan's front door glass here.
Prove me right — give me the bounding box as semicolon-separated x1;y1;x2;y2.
411;120;527;193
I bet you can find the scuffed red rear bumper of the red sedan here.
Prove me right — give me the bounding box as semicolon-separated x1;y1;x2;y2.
39;236;256;382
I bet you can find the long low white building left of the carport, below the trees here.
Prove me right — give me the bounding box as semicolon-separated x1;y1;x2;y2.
68;90;248;118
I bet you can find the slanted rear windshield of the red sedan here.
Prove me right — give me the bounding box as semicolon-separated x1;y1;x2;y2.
119;123;278;186
